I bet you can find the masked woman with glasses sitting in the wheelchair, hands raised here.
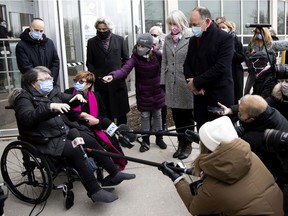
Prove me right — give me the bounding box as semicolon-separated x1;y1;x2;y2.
14;66;135;203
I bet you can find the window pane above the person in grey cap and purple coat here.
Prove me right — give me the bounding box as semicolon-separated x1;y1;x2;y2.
144;0;165;32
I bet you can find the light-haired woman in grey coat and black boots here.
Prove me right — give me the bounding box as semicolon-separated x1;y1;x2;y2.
160;10;194;159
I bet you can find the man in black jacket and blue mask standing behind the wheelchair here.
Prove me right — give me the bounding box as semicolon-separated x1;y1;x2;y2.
16;18;60;85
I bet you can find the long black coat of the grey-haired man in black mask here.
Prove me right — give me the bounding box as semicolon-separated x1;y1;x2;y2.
86;34;130;118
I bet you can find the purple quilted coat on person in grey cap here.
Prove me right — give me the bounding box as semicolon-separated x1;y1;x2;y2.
109;51;165;112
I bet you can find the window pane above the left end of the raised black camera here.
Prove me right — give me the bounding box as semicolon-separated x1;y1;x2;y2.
242;0;258;34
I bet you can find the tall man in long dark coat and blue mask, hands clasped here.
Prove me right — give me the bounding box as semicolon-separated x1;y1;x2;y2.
184;7;234;129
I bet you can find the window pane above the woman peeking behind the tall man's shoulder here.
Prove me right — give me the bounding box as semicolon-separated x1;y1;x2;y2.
223;0;241;34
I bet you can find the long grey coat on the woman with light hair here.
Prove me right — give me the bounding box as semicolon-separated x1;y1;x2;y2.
160;30;194;109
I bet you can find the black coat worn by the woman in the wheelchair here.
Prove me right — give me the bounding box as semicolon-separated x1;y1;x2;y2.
14;86;94;156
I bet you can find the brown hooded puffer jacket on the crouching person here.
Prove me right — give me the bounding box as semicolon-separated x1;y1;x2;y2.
175;138;284;216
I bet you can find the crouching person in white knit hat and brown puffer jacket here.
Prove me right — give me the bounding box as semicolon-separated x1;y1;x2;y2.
160;116;284;216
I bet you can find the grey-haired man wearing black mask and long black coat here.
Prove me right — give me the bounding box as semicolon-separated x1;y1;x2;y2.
86;17;130;125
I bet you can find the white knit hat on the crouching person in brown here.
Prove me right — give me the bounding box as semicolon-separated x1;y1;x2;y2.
199;116;238;151
